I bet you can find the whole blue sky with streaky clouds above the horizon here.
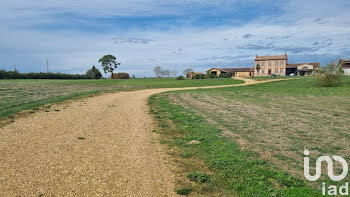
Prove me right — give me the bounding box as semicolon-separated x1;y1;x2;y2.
0;0;350;77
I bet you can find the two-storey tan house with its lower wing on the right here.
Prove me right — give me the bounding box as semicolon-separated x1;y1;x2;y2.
254;53;320;76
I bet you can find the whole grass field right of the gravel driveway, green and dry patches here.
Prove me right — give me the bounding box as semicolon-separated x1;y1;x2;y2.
150;77;350;196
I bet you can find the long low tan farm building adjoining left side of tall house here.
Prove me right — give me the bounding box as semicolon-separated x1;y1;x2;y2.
207;68;254;77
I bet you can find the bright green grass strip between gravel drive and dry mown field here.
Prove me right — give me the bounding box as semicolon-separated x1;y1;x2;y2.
150;92;319;196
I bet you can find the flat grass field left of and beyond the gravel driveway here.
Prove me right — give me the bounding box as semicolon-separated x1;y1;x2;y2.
0;78;242;118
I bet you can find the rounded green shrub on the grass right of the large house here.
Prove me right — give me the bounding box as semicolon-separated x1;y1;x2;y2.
318;62;343;87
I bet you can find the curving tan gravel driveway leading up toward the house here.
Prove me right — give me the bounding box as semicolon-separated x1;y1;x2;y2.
0;79;284;196
